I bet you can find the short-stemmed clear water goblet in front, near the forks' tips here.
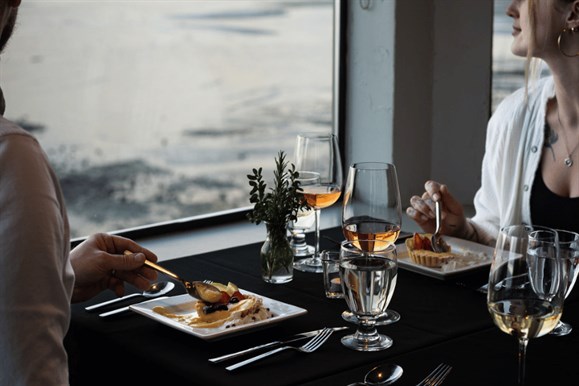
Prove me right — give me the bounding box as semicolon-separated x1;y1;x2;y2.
340;240;398;351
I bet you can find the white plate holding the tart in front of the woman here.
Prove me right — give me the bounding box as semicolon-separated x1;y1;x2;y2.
396;236;494;279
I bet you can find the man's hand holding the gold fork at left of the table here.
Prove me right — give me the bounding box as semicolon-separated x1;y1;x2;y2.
70;233;157;303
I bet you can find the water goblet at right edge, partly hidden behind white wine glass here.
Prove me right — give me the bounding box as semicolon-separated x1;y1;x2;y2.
551;229;579;336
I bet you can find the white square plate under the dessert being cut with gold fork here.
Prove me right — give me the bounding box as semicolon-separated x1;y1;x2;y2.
130;290;308;340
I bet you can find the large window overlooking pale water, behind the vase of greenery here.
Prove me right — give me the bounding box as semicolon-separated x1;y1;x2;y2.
2;0;334;237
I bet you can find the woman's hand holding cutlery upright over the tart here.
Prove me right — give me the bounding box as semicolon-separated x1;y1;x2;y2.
406;181;470;238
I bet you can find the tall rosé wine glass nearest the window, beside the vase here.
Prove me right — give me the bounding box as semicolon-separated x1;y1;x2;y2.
294;133;342;273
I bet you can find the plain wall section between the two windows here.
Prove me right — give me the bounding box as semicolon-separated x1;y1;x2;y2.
345;0;493;211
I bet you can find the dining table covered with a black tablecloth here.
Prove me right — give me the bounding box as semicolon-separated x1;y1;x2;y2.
65;227;579;386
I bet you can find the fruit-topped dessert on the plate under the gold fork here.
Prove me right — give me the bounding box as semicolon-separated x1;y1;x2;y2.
153;282;273;328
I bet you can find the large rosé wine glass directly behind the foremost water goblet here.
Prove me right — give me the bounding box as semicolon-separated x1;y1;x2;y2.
342;162;402;325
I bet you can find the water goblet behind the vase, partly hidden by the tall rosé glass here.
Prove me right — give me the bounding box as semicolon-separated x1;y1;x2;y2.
287;172;320;258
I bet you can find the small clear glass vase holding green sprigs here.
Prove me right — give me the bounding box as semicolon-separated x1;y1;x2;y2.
259;226;294;284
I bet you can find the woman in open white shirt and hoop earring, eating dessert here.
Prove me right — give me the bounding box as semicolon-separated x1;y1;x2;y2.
406;0;579;245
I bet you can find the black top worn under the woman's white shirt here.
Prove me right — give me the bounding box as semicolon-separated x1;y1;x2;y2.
531;164;579;232
